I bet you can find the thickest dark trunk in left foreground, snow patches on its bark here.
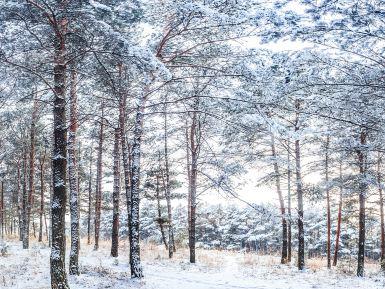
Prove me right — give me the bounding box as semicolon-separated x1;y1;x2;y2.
50;10;69;289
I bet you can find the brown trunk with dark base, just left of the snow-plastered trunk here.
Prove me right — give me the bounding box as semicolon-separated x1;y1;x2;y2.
111;128;121;257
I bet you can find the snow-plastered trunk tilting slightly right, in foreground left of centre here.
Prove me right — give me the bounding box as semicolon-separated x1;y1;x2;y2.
129;95;145;278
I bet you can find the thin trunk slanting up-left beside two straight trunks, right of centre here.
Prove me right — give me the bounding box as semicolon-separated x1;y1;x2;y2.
270;133;287;264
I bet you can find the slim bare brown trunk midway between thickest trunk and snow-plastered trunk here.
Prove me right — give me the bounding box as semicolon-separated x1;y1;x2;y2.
94;103;104;250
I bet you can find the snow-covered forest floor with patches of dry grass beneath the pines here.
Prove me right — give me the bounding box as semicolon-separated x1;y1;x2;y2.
0;236;385;289
